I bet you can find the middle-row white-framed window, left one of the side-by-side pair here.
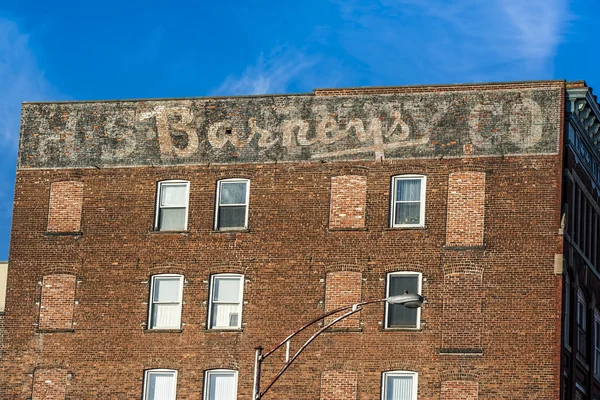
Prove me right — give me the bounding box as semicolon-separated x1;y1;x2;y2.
148;275;183;329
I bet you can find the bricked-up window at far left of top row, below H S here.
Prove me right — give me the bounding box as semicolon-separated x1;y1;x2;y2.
48;181;83;232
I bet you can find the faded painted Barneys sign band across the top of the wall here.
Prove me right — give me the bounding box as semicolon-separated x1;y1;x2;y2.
19;88;561;168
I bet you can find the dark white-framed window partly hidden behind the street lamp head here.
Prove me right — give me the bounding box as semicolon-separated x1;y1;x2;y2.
385;272;421;328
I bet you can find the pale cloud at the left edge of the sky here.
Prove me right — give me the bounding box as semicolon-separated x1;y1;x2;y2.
0;18;61;147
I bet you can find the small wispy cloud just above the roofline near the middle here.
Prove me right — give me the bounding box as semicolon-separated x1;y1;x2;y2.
211;47;322;96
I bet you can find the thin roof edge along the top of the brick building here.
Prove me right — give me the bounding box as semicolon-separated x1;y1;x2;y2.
22;79;568;105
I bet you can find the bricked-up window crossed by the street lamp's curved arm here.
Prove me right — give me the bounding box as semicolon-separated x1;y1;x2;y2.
325;271;362;328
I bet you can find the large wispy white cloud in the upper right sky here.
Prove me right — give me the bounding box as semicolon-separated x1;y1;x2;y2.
333;0;570;84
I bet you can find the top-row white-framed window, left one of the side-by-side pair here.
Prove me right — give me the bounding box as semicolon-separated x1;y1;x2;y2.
154;181;190;231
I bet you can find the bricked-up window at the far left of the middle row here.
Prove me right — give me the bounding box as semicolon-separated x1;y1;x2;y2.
40;274;75;330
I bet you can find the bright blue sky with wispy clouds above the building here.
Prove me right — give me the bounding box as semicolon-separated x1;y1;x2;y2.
0;0;600;259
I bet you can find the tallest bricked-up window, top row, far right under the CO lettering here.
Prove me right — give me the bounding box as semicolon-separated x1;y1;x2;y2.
446;171;485;246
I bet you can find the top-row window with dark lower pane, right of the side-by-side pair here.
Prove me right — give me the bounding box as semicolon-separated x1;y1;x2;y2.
215;179;250;230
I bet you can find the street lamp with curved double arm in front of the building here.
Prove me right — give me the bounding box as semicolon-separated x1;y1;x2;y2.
253;293;423;400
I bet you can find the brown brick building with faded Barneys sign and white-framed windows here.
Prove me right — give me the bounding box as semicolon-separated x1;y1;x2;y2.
0;81;600;400
